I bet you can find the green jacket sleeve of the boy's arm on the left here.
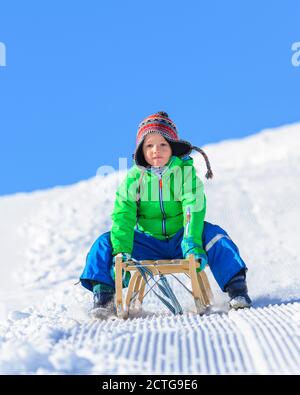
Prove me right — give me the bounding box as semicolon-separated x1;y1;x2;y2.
110;173;138;255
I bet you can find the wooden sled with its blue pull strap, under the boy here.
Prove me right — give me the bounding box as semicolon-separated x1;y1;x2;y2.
115;255;213;319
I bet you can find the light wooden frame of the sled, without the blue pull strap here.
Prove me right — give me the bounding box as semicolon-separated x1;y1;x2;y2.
115;255;213;319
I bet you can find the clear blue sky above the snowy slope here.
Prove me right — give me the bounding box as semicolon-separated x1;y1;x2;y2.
0;0;300;195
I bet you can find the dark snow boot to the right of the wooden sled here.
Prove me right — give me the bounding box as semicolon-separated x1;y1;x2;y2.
225;269;252;310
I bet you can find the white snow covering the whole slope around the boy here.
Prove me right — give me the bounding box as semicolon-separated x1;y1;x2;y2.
0;124;300;374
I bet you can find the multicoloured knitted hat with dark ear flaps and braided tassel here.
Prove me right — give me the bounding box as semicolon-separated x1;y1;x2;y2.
133;111;213;178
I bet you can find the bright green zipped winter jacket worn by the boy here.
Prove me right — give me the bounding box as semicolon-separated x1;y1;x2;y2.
111;156;206;258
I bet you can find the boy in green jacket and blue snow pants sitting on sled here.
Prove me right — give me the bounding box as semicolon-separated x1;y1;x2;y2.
80;111;252;316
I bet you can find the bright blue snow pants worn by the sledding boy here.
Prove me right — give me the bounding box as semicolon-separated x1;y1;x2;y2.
80;221;247;291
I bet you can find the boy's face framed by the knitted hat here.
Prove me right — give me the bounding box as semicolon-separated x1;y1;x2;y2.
143;133;172;167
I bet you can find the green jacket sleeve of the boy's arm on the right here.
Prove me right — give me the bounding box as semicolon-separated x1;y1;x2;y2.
181;165;206;259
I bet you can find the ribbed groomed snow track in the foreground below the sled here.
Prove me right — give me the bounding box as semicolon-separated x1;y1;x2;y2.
67;303;300;374
